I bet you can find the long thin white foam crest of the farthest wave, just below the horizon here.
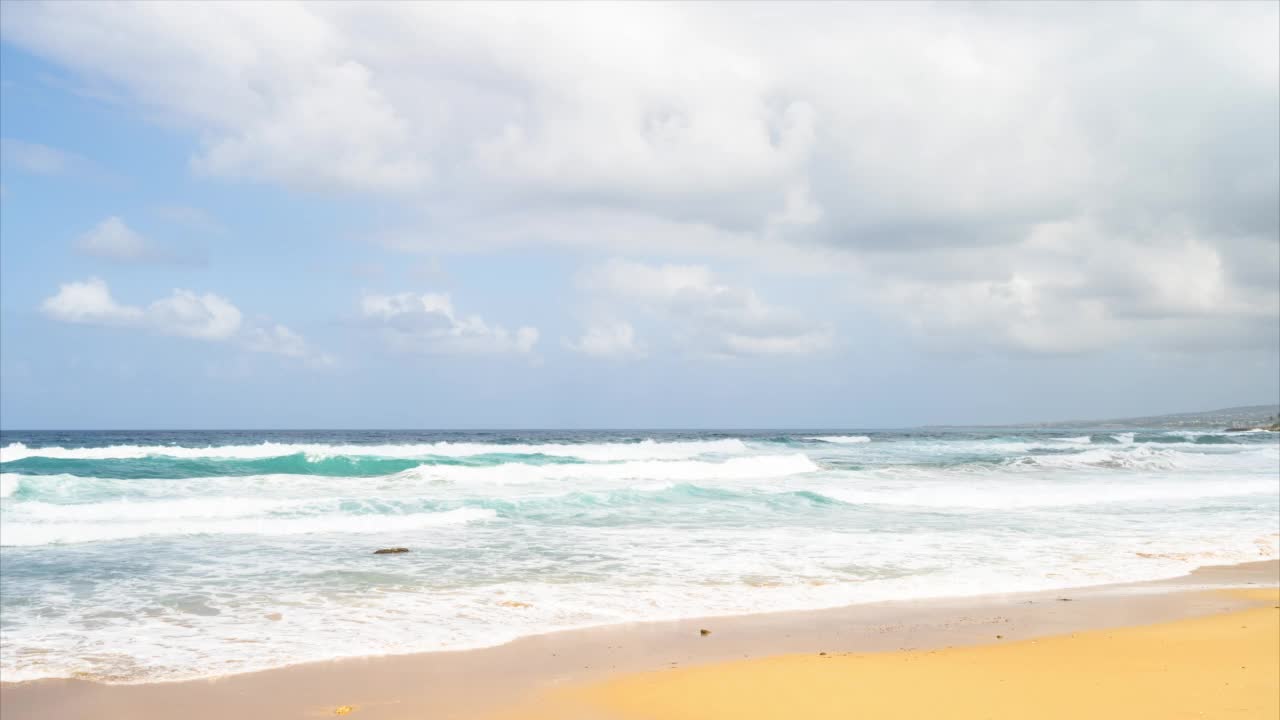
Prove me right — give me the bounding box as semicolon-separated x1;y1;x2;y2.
0;438;746;462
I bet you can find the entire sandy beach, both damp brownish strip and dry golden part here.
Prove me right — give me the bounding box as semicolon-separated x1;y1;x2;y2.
0;561;1280;720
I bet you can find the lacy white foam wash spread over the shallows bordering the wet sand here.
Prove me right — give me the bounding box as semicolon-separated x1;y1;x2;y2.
4;515;1274;683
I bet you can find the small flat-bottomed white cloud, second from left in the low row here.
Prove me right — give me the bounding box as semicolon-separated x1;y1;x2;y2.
360;292;538;355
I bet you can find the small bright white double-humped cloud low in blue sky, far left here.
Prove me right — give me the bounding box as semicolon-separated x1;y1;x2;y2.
40;278;334;365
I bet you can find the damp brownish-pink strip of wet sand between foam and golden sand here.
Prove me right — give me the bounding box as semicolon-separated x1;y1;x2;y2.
0;560;1280;720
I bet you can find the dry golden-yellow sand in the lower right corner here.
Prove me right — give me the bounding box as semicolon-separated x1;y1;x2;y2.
500;589;1280;720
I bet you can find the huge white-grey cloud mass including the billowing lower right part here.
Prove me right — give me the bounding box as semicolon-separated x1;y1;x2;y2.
4;3;1280;352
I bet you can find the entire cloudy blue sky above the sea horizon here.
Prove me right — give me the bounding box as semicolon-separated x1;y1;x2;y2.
0;1;1280;429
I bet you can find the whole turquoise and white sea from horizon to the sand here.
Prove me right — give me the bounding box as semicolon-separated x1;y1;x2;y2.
0;428;1280;683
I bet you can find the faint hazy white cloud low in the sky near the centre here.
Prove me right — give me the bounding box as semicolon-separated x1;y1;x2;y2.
579;260;833;356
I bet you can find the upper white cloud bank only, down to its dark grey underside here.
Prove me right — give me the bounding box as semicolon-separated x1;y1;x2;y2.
5;3;1280;222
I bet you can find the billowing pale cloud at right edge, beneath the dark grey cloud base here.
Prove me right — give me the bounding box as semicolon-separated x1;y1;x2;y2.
863;222;1280;354
